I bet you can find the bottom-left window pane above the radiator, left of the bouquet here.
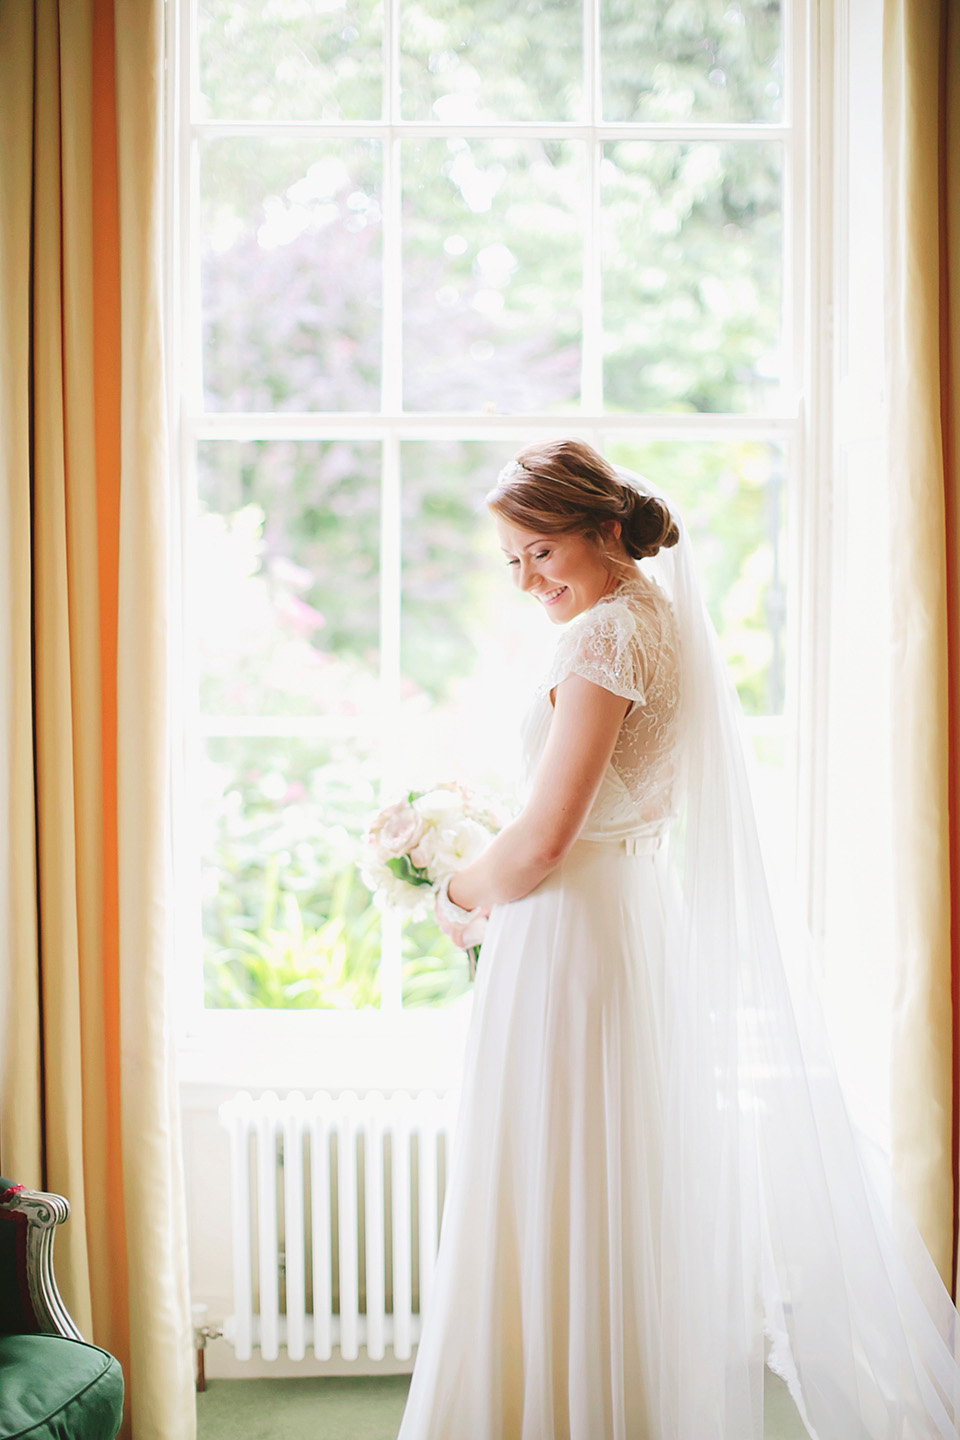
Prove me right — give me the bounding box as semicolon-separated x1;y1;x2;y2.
201;737;380;1009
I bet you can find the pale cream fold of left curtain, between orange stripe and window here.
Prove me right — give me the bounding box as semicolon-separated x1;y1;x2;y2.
115;8;196;1437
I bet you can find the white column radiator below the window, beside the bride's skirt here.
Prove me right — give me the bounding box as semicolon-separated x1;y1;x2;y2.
220;1090;456;1361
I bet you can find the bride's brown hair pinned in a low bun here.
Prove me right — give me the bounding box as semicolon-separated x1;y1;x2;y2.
486;441;679;560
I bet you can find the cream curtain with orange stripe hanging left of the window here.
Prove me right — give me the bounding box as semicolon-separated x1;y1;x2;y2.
0;0;194;1440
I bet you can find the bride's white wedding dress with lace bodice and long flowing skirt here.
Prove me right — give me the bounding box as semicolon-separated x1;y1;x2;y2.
399;572;682;1440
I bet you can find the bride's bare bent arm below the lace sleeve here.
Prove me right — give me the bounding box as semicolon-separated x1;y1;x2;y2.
448;675;630;910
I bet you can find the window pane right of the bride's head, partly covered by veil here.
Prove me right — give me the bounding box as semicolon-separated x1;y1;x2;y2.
606;441;787;716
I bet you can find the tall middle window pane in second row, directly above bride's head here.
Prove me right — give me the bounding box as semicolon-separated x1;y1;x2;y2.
403;140;583;412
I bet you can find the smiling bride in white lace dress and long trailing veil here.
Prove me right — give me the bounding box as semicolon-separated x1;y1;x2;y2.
399;441;960;1440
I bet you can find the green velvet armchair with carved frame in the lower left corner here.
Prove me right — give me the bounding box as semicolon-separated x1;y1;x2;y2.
0;1179;124;1440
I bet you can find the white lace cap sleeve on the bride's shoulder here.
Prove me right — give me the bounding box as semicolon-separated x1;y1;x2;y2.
540;600;648;706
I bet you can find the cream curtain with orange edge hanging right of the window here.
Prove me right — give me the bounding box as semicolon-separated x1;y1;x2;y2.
884;0;960;1286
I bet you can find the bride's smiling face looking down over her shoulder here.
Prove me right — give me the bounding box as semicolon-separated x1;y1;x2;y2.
494;516;616;625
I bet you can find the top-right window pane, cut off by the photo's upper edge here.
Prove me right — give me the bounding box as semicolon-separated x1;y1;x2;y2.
600;0;783;122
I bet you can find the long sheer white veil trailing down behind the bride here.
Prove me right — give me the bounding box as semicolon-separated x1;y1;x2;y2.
619;469;960;1440
